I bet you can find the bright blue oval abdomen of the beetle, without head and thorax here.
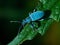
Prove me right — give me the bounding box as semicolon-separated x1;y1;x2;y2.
29;11;44;21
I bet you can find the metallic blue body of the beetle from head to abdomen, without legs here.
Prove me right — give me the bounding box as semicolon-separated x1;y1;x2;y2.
22;11;44;25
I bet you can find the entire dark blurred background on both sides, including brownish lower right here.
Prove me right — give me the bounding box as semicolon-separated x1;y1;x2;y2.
0;0;60;45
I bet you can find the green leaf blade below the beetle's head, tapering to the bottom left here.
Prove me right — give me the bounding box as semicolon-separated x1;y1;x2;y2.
8;24;37;45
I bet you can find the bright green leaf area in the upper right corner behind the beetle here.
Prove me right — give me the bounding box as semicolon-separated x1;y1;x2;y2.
40;0;60;22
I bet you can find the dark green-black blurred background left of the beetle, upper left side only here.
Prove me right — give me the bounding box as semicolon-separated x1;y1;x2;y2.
0;0;38;45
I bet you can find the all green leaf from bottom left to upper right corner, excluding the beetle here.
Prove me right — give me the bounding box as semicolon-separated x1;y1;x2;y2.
8;0;60;45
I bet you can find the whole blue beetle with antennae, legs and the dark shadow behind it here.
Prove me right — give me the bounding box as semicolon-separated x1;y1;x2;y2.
10;10;51;30
